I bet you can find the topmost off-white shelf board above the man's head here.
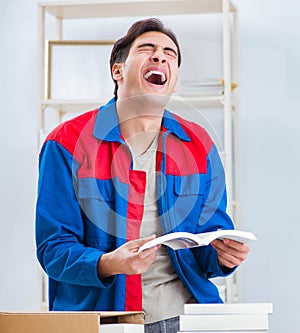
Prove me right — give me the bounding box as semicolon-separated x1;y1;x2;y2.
39;0;236;19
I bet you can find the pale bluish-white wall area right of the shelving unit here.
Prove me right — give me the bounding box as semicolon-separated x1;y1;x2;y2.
237;0;300;333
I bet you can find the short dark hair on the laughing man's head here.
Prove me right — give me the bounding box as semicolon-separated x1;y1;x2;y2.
110;18;181;98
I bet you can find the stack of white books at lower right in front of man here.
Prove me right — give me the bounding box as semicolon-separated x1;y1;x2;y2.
178;303;273;333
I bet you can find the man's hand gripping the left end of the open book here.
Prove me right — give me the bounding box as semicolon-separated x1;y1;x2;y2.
98;235;160;279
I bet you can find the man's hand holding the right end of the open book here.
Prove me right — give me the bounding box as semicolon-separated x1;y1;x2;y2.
211;239;250;269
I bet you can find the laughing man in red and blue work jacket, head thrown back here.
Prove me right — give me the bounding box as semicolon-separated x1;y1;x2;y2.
36;19;249;333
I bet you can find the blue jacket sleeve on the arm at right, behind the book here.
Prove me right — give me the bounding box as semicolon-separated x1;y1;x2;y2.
193;146;234;277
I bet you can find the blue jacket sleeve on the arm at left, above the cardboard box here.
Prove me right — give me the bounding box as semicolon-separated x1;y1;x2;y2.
36;141;114;288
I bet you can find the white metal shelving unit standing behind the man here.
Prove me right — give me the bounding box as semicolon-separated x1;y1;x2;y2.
38;0;240;302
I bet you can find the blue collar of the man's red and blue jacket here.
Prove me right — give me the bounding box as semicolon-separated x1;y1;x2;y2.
94;98;191;142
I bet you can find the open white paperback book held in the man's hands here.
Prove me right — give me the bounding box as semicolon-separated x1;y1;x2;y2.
139;229;256;252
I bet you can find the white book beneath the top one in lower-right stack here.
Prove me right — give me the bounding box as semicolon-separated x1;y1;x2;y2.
179;313;269;331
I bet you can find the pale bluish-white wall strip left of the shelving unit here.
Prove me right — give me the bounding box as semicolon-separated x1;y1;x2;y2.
0;0;40;311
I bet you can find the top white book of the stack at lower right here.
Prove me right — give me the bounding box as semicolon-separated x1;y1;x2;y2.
184;303;273;315
